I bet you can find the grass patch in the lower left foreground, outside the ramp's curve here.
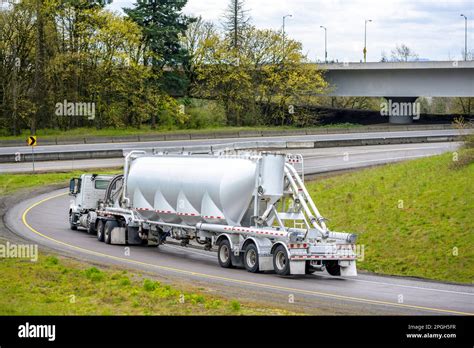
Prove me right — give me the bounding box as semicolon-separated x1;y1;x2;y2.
0;254;295;315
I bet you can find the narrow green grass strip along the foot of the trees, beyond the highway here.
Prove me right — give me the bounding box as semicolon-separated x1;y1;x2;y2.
0;123;359;140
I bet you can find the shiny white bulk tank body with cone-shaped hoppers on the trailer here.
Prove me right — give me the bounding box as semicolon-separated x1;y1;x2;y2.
126;156;258;226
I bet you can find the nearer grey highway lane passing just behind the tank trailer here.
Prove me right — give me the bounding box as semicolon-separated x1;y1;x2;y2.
0;142;460;174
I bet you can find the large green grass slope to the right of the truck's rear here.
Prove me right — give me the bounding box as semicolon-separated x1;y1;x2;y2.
308;150;474;283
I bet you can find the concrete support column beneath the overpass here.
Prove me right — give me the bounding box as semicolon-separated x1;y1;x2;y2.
380;97;420;124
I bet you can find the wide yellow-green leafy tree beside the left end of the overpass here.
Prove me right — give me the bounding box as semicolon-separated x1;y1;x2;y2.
195;27;326;126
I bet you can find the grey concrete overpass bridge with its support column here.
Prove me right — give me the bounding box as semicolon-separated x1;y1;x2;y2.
319;61;474;124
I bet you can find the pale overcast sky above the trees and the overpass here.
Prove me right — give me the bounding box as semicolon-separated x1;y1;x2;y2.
109;0;474;61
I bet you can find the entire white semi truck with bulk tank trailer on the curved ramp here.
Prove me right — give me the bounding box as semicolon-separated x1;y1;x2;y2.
69;151;357;276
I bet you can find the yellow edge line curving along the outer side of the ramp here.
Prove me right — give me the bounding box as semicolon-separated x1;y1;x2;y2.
22;193;474;315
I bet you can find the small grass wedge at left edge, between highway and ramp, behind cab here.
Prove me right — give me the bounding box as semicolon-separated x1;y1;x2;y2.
0;170;122;196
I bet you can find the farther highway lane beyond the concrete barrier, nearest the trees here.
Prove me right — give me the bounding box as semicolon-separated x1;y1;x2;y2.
0;130;466;155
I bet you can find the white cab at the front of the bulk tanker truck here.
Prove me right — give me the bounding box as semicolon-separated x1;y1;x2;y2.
69;174;114;234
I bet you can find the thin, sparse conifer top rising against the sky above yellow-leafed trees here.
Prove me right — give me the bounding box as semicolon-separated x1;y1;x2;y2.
223;0;250;49
